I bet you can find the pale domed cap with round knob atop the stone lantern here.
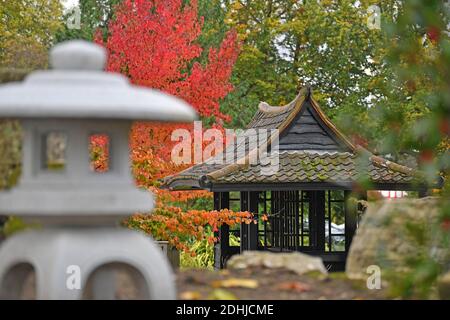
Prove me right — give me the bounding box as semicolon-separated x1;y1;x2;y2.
0;40;197;122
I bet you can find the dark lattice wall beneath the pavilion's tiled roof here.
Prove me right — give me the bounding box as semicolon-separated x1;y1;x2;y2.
215;190;356;270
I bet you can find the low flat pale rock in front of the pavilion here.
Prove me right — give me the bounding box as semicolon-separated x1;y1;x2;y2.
227;251;327;275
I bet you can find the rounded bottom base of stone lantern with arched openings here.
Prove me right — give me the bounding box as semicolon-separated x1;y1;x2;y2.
0;228;175;300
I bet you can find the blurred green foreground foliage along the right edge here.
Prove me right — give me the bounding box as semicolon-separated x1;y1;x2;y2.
375;0;450;298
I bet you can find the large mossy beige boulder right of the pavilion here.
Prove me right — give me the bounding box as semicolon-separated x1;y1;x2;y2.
346;197;448;279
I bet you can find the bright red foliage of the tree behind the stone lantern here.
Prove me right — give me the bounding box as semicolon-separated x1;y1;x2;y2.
96;0;239;202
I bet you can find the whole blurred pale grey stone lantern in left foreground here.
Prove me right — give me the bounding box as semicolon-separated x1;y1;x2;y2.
0;41;196;299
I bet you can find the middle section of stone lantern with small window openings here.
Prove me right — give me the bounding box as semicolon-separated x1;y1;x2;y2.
0;119;153;225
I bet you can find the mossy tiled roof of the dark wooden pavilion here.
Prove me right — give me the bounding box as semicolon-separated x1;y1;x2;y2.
162;87;432;190
